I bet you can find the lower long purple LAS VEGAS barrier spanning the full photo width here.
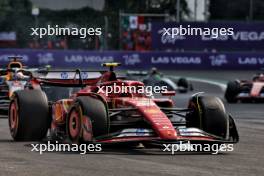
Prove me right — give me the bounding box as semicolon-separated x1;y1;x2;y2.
0;49;264;70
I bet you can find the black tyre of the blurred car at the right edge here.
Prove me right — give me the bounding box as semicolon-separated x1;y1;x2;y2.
225;81;240;103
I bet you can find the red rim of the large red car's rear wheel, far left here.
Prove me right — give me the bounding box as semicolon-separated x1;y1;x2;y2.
9;101;18;136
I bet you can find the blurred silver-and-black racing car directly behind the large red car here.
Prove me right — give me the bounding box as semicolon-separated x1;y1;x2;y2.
126;68;193;93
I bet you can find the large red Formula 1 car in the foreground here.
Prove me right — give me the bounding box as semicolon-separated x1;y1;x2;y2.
9;63;239;147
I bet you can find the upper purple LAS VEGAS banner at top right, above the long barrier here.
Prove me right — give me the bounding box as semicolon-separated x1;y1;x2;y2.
151;22;264;51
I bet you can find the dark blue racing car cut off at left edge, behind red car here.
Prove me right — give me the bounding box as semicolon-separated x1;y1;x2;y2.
0;57;32;113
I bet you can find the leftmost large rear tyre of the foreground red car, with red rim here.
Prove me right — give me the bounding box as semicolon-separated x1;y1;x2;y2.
8;90;50;141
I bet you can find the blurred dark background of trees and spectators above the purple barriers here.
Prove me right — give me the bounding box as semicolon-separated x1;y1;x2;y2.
0;0;264;51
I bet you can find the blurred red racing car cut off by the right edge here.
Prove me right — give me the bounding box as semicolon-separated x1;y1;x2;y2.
225;73;264;103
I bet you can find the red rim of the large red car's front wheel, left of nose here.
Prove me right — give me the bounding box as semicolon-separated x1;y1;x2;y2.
69;109;80;139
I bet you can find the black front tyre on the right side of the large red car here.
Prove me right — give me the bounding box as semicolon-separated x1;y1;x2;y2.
186;96;229;138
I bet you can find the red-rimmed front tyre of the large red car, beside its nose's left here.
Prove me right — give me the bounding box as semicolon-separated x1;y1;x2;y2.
66;96;109;143
